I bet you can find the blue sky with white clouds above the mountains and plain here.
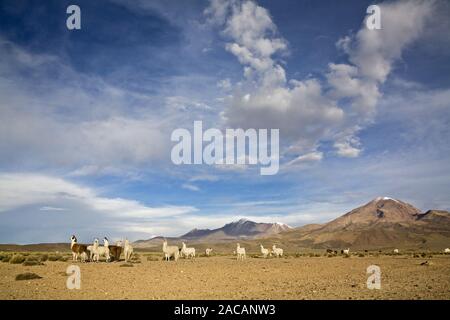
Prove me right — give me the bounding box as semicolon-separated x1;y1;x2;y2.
0;0;450;243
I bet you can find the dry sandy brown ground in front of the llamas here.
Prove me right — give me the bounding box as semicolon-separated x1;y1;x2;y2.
0;255;450;300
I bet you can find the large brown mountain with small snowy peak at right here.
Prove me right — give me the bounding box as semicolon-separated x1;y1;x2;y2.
280;197;450;249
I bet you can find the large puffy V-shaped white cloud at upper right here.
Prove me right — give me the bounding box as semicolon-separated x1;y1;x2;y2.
205;0;433;157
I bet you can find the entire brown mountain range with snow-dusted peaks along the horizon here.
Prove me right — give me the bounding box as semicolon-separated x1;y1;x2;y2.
135;197;450;249
